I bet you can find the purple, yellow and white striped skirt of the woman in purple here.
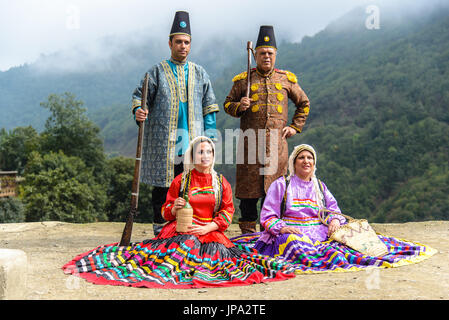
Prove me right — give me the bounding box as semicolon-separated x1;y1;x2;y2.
231;232;437;274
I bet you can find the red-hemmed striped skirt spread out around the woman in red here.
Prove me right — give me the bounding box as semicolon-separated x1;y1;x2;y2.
63;234;295;289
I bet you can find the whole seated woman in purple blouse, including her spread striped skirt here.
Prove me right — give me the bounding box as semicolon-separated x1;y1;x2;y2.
231;144;436;273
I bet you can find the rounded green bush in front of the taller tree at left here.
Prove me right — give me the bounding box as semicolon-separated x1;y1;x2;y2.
21;151;107;222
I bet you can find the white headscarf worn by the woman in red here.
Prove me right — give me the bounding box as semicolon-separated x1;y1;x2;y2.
181;136;220;212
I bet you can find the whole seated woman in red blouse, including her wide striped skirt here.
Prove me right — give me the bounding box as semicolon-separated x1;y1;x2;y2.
63;137;294;288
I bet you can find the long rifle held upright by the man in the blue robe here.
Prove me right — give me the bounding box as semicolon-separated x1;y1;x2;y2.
120;73;148;246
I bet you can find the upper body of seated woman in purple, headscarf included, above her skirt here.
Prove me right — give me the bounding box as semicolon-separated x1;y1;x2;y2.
259;145;346;245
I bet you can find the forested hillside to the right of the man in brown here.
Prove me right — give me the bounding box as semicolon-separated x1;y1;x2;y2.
279;9;449;222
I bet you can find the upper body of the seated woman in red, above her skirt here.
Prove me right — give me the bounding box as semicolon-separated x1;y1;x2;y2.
159;137;238;248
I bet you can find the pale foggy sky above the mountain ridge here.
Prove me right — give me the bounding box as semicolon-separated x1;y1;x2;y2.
0;0;443;71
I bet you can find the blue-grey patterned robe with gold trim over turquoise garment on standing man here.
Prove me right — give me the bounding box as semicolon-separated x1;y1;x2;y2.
132;60;219;187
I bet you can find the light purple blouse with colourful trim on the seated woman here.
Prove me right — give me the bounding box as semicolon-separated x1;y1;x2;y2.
259;175;346;243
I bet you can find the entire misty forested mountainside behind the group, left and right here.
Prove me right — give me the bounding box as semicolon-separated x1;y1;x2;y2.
0;7;449;222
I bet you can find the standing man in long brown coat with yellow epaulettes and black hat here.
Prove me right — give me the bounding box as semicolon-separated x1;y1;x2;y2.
224;26;310;234
